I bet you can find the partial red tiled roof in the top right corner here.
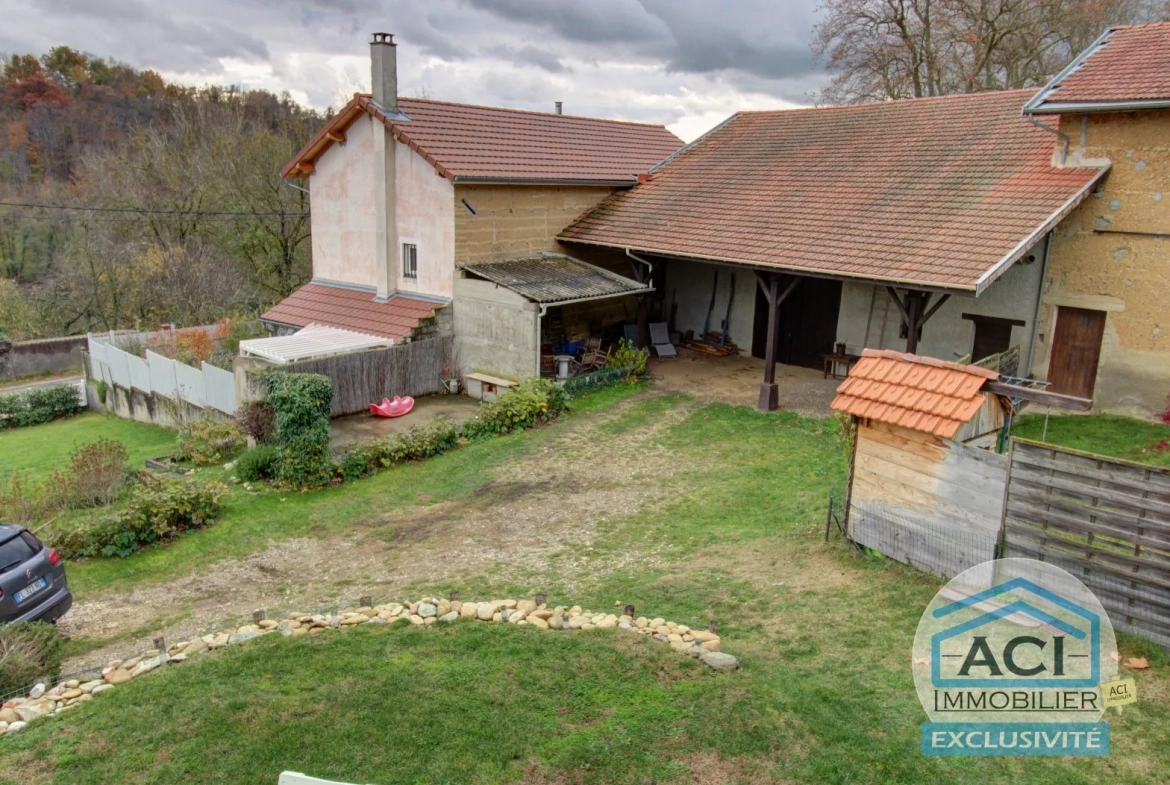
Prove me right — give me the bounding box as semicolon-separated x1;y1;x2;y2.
1028;22;1170;112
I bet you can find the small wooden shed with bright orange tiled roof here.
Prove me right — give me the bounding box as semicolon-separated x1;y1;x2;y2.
832;350;1011;576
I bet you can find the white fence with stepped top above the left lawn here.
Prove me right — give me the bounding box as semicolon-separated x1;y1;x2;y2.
89;335;236;414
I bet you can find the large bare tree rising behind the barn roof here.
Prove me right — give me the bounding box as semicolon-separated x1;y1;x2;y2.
812;0;1166;103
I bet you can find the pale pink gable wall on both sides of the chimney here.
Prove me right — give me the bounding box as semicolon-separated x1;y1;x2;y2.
309;117;455;297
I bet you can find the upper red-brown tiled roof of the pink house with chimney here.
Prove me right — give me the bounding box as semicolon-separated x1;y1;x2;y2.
281;95;682;184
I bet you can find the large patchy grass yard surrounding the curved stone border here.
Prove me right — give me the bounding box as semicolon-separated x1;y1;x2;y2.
0;390;1170;785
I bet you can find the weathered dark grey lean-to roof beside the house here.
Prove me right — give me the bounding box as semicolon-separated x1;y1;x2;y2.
460;254;647;303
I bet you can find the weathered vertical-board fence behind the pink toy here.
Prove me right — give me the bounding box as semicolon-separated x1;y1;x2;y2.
280;337;454;416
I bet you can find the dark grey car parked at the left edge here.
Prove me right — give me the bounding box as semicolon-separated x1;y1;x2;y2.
0;523;73;624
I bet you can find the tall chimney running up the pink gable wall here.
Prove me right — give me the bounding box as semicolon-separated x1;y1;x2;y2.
370;33;400;302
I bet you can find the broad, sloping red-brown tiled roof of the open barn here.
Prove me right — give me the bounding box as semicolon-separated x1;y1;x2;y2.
560;90;1104;292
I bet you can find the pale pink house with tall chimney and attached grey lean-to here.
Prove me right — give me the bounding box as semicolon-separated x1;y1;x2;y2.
262;33;682;378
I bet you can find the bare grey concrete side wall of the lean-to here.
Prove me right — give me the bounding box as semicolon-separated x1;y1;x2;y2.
452;278;541;379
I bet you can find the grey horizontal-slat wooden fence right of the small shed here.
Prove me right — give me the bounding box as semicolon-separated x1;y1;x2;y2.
1004;440;1170;646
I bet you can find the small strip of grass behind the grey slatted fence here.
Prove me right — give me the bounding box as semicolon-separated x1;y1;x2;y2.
1012;414;1170;467
